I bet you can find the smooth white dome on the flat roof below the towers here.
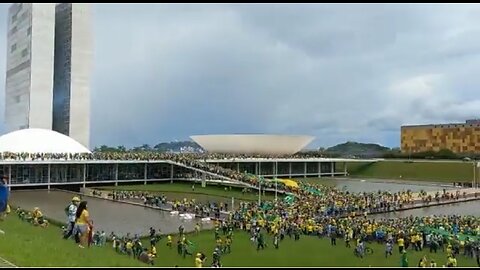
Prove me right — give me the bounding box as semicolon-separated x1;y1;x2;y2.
0;128;91;154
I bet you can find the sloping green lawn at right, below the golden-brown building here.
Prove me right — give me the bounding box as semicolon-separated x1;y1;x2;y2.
347;161;473;183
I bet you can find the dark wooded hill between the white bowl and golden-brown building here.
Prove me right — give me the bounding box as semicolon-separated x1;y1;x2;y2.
325;142;390;157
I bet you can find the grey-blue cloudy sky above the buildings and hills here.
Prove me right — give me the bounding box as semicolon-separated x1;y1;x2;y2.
0;4;480;147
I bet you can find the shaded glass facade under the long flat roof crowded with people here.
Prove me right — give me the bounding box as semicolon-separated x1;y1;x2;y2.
0;162;343;185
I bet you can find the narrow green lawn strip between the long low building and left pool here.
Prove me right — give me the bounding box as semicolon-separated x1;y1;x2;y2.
99;182;283;203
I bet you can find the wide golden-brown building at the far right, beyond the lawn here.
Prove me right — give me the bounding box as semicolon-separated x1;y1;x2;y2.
401;119;480;153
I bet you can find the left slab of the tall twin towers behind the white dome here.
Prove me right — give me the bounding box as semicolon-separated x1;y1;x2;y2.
5;4;55;131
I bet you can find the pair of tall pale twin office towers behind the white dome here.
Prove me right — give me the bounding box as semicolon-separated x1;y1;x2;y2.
5;3;92;147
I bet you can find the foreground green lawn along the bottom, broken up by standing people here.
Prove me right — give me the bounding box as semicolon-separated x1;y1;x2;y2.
0;213;476;267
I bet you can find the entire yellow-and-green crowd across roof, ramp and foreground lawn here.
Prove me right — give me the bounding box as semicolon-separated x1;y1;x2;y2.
5;152;480;267
